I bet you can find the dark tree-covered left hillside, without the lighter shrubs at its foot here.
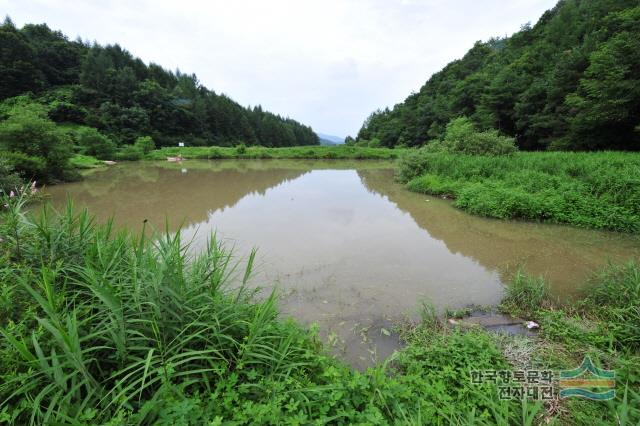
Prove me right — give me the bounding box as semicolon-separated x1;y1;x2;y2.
0;18;319;146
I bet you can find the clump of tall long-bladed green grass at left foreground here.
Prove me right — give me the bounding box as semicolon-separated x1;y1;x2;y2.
0;193;314;424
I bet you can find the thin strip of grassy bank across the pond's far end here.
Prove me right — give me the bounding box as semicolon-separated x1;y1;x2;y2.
146;145;403;160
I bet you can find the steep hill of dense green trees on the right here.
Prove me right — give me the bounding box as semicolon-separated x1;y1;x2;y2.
357;0;640;150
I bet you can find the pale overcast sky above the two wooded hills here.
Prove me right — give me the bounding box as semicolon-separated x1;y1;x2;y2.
0;0;556;136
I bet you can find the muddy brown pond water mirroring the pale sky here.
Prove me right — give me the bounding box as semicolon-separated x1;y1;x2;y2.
46;160;640;368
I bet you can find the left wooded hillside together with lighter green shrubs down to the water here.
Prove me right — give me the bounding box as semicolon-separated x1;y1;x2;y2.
0;18;319;186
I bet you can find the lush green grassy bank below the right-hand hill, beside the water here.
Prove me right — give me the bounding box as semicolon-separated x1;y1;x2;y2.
398;150;640;233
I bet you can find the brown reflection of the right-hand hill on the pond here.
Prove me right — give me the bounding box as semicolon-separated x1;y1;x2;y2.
358;170;640;297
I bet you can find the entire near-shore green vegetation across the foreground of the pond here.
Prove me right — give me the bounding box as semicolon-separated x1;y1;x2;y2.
0;186;640;425
